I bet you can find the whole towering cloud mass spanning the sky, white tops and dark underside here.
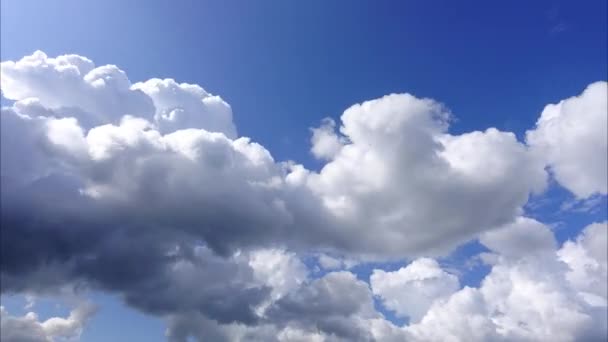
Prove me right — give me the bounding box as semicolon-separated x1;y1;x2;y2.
0;52;606;341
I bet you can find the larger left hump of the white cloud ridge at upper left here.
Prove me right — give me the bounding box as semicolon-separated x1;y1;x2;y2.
1;51;154;127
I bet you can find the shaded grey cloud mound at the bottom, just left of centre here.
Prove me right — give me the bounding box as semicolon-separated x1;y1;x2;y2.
168;272;380;341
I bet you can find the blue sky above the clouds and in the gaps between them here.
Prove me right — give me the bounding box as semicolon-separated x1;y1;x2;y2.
0;0;608;341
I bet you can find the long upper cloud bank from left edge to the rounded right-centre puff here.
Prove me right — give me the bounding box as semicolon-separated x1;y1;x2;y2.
2;52;545;257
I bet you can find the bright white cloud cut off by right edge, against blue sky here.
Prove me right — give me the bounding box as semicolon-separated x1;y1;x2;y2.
526;82;608;198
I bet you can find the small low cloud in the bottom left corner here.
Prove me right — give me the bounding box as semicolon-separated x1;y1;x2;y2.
0;302;96;342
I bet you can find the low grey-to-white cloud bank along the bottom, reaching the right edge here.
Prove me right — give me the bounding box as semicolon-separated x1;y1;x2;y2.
170;218;608;342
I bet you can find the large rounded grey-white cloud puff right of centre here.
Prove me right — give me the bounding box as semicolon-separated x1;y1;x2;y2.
308;94;545;255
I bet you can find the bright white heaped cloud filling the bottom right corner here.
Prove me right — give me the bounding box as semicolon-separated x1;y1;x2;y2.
376;219;608;341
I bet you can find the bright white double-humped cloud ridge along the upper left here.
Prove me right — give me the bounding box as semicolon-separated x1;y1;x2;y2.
1;51;236;138
